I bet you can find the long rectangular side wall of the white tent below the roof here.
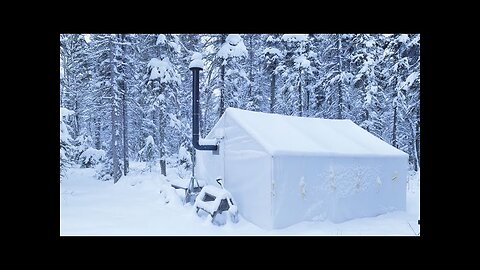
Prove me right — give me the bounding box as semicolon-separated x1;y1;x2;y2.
272;155;408;228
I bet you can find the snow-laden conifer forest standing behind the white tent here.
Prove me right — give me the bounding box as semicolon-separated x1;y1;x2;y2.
60;34;420;182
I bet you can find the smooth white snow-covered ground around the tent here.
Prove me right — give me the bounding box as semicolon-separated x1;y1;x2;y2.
60;162;420;236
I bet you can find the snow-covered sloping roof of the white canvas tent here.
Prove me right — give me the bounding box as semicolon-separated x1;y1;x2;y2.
225;108;406;156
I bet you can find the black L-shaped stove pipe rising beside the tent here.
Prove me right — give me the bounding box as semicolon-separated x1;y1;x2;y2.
190;64;218;151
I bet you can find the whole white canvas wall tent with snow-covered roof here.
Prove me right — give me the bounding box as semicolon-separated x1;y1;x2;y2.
195;108;408;229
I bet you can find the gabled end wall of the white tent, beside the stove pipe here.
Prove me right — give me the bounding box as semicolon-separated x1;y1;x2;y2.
196;114;272;228
